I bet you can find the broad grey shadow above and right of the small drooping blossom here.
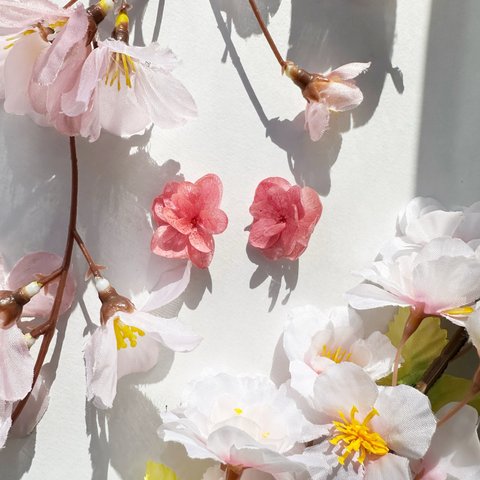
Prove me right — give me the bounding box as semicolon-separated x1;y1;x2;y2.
287;0;404;127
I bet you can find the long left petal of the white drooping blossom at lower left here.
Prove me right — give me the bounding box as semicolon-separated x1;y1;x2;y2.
84;320;117;409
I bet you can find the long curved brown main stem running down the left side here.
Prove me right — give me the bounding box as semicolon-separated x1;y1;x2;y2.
12;137;78;422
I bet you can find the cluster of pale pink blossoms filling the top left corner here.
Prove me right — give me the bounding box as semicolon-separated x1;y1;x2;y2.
0;0;196;141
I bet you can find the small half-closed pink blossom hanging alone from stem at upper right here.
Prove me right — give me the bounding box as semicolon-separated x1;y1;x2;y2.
285;62;370;142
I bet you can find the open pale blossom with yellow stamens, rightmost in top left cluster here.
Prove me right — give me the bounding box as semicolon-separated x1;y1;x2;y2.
61;39;196;141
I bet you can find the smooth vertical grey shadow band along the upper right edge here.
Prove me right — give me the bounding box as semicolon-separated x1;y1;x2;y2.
416;0;480;206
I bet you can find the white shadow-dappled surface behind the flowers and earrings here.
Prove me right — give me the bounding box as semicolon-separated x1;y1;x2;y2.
0;0;480;480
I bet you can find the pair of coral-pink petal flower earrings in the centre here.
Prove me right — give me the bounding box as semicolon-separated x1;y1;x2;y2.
151;173;323;268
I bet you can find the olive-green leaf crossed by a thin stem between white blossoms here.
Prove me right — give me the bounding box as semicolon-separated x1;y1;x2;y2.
378;308;448;385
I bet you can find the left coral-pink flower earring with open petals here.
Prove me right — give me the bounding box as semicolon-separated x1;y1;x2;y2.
151;173;228;268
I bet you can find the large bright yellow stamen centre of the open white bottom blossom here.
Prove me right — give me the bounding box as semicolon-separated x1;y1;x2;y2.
330;405;389;465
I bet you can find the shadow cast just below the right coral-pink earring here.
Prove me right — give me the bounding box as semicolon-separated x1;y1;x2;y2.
246;245;299;312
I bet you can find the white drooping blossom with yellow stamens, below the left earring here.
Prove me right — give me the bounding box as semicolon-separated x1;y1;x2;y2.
84;278;202;409
